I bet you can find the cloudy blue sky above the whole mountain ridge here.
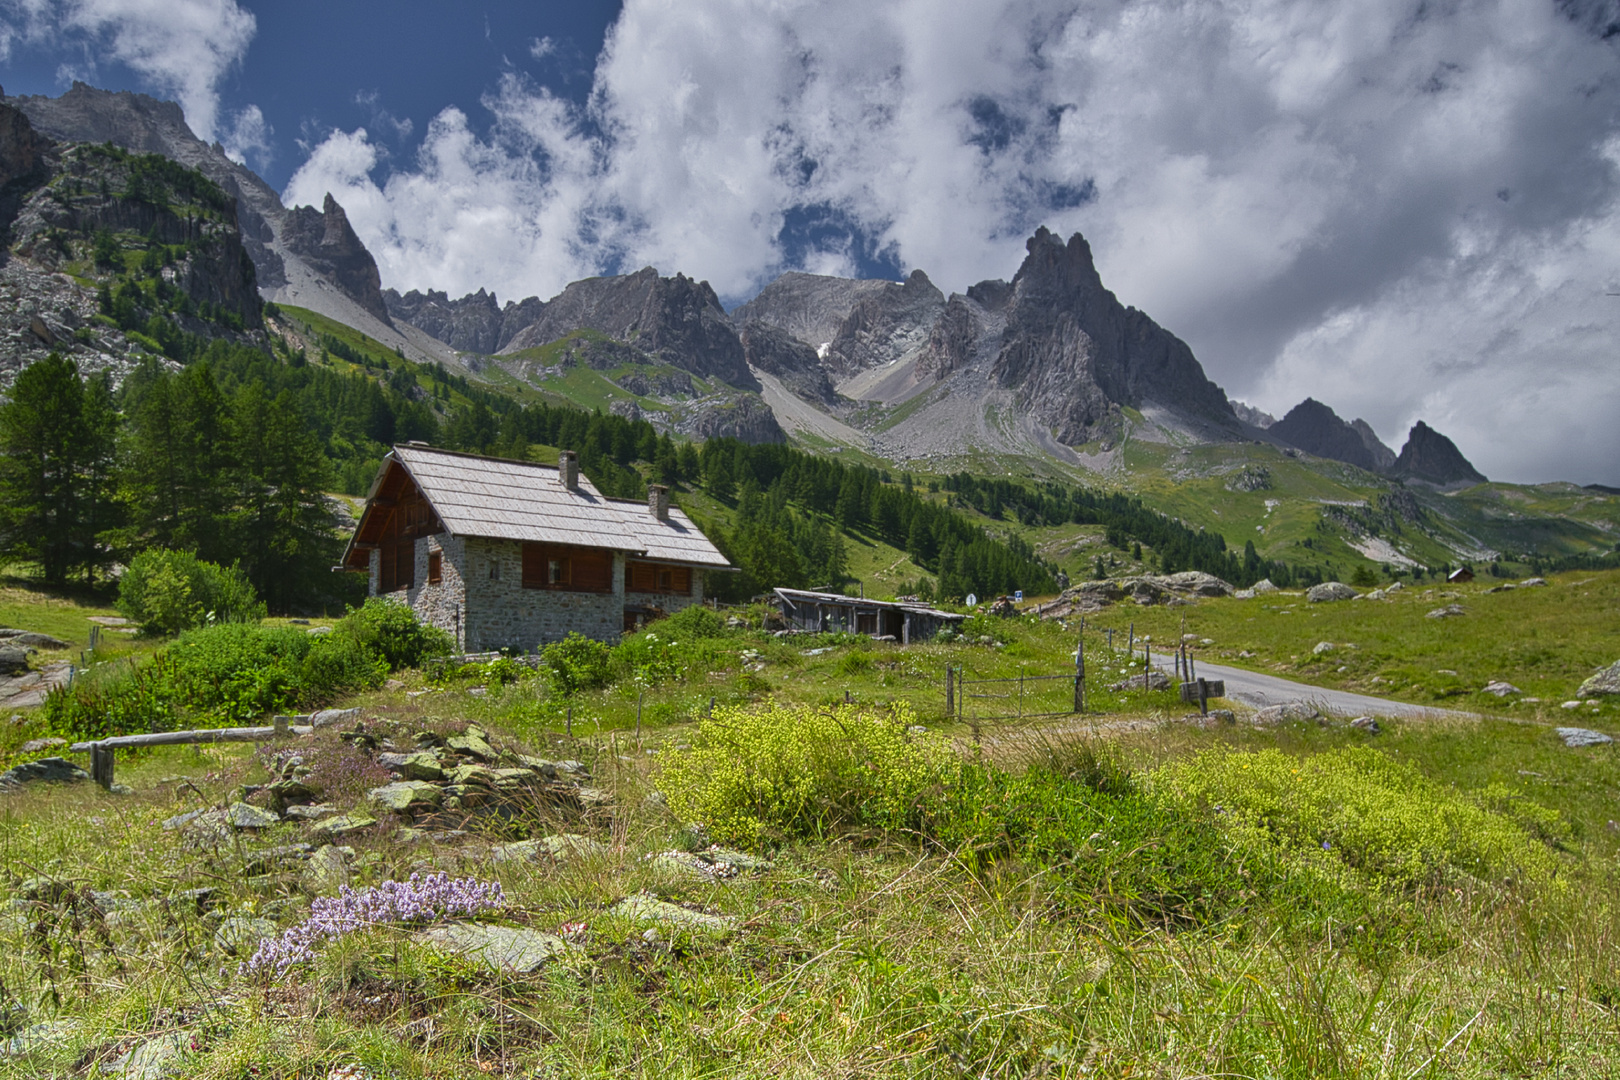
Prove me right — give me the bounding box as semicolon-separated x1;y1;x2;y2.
0;0;1620;484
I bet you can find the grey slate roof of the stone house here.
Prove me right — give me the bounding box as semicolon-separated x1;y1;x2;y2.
356;445;731;568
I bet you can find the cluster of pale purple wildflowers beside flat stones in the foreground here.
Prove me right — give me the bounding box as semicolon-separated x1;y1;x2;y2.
241;873;505;976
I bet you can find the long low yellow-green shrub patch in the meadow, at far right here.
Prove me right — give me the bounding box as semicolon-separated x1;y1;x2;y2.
1155;746;1557;889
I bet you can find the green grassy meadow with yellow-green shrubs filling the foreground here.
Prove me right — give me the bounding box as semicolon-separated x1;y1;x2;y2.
0;572;1620;1080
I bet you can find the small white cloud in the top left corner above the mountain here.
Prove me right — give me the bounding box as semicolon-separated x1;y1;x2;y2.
0;0;256;139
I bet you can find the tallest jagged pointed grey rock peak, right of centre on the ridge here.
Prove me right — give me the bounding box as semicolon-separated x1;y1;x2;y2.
993;228;1236;444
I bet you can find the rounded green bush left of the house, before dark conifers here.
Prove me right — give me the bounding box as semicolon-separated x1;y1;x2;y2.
118;547;266;636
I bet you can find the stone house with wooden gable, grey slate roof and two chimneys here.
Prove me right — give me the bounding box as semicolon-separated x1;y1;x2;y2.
343;444;734;653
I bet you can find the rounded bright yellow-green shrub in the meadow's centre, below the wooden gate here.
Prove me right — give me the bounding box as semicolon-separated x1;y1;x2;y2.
658;703;961;845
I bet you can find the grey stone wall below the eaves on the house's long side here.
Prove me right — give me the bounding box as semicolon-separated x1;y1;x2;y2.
466;538;624;653
